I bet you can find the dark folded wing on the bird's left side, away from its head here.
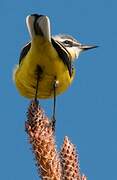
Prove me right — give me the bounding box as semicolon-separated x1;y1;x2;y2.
19;42;31;64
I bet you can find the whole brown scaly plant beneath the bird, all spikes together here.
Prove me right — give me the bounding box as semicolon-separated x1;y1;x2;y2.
25;101;87;180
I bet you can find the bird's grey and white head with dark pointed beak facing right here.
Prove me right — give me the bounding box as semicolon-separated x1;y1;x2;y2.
53;35;98;61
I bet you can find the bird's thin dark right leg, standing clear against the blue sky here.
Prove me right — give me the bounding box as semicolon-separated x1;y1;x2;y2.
51;77;58;131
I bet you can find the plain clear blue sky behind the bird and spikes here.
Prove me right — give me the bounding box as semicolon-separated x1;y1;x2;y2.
0;0;117;180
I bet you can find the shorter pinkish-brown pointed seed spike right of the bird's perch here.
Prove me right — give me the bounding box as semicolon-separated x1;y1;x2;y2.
60;136;81;180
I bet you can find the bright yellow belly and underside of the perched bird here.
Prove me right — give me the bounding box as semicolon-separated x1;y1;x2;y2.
14;36;74;99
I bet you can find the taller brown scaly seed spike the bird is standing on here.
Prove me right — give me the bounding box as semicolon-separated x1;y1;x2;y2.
26;101;61;180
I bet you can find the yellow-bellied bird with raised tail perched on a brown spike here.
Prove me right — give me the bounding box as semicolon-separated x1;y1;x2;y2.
13;14;98;124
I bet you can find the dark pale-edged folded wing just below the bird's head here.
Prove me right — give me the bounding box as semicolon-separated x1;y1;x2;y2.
51;38;72;77
